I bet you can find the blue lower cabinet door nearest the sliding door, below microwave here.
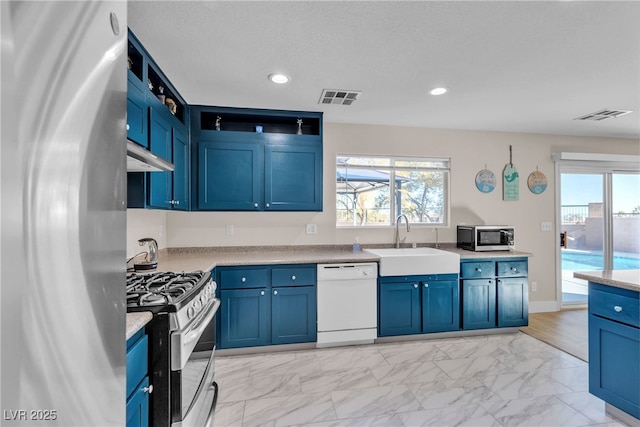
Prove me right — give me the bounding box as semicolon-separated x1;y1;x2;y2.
498;277;529;327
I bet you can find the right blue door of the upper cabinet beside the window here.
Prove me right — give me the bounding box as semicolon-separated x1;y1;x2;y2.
264;140;322;211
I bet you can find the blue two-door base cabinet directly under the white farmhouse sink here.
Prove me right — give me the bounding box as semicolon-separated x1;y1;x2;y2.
378;274;460;336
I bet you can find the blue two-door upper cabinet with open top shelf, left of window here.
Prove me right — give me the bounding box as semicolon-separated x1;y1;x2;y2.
191;106;322;211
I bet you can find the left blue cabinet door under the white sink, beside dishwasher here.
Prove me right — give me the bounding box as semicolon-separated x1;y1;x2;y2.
378;282;422;336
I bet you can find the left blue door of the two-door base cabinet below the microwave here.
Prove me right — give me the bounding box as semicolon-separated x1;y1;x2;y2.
462;279;496;329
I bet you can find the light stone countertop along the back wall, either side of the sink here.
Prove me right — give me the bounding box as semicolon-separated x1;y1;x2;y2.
148;244;532;271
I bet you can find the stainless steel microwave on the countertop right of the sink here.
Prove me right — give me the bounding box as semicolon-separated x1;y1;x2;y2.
457;225;515;252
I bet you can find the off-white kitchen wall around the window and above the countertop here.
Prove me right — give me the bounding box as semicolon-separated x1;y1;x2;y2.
127;123;640;303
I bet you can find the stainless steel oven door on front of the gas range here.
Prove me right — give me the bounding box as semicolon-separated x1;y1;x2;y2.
171;300;220;426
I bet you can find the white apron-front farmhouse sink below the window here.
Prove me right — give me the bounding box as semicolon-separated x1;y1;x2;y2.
364;248;460;276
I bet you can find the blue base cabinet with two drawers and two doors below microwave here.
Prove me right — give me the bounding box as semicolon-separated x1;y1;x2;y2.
460;257;529;329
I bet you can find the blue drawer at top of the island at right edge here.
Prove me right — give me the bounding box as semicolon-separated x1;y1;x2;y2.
589;286;640;328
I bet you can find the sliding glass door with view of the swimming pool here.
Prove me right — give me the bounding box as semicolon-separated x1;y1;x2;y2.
560;166;640;306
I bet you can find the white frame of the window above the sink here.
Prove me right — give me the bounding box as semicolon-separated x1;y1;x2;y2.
333;153;451;229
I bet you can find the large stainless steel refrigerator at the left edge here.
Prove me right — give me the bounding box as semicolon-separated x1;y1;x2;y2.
0;1;127;426
